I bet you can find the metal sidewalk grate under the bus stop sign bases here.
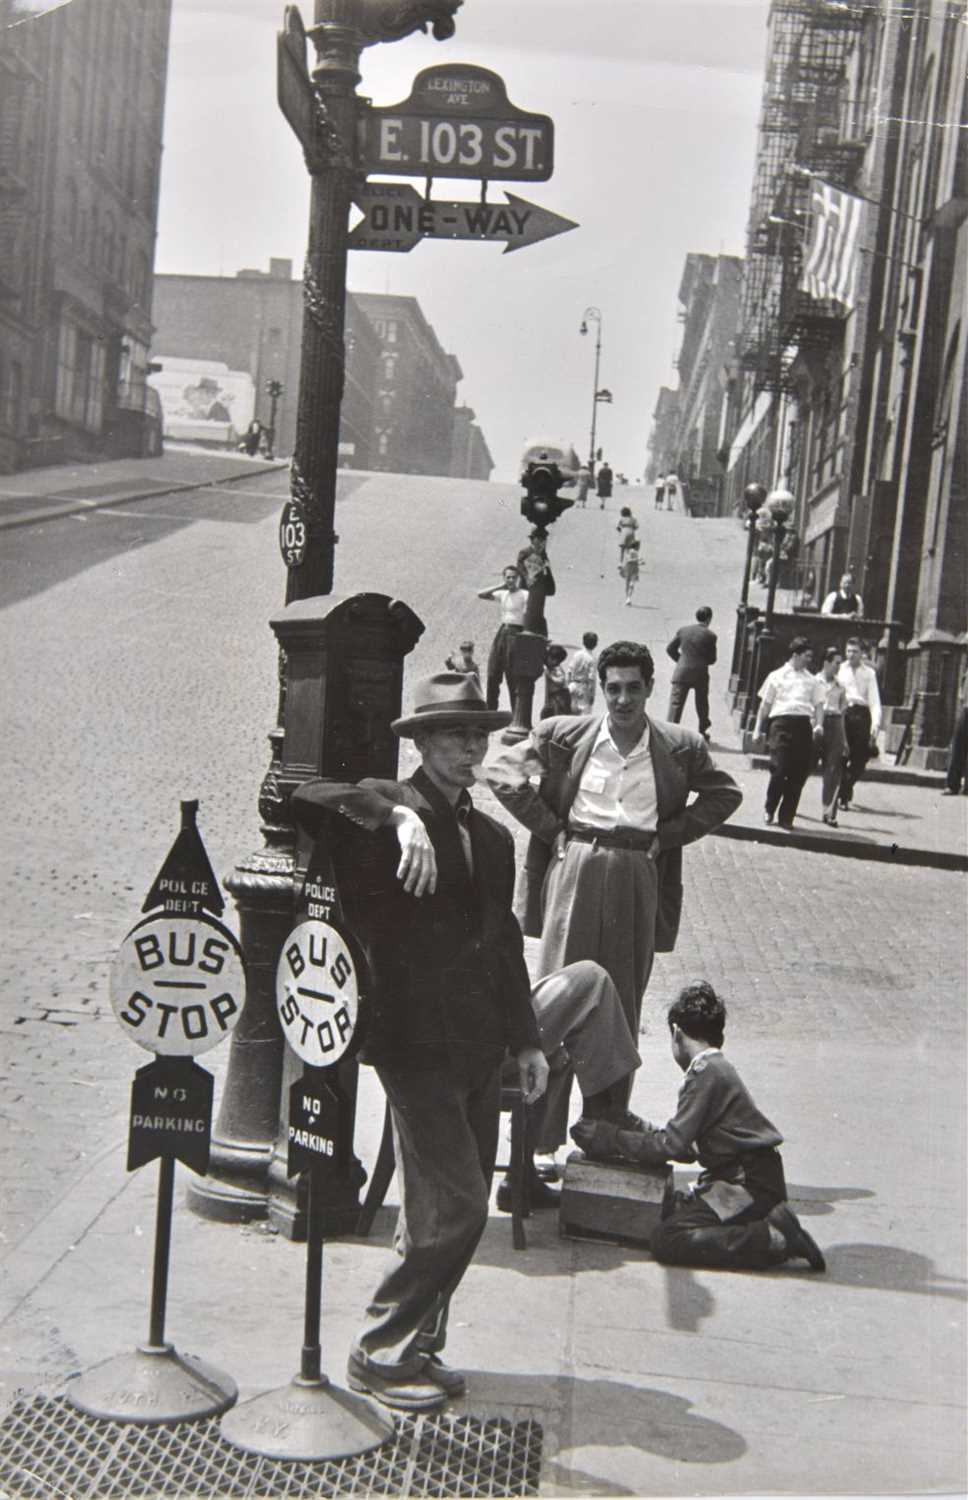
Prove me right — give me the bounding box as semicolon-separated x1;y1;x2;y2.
0;1397;543;1500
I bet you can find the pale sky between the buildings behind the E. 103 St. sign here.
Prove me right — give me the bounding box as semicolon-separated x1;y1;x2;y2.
156;0;768;480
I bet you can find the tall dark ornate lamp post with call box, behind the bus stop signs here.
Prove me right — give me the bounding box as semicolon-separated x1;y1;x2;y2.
189;0;462;1235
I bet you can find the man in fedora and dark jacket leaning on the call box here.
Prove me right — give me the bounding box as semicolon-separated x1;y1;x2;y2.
286;672;548;1412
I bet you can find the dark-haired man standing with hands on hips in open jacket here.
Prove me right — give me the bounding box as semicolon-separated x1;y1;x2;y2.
488;641;743;1146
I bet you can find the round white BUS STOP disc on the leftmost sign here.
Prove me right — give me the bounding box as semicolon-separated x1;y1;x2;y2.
111;912;245;1058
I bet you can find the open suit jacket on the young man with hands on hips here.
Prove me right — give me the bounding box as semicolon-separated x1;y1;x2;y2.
489;714;743;953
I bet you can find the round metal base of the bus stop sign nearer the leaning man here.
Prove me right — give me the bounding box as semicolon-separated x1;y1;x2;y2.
222;1376;393;1463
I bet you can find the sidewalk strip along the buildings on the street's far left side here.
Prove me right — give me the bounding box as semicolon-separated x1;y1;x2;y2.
0;449;288;530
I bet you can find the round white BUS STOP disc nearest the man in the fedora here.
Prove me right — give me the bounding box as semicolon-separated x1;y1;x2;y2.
276;920;359;1068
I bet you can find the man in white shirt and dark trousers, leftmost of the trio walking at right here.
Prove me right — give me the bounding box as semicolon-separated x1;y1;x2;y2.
753;636;824;831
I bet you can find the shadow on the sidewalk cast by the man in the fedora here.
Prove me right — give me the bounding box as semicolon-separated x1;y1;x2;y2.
471;1371;747;1476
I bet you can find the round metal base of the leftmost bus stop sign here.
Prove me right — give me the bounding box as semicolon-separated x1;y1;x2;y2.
65;1344;239;1427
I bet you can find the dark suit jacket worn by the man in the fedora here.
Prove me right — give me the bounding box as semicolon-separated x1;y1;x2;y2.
293;771;540;1068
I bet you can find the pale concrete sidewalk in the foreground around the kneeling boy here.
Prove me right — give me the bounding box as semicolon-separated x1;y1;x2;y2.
3;1038;965;1497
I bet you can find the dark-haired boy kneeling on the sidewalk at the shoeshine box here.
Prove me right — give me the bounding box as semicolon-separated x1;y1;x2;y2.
572;980;827;1271
